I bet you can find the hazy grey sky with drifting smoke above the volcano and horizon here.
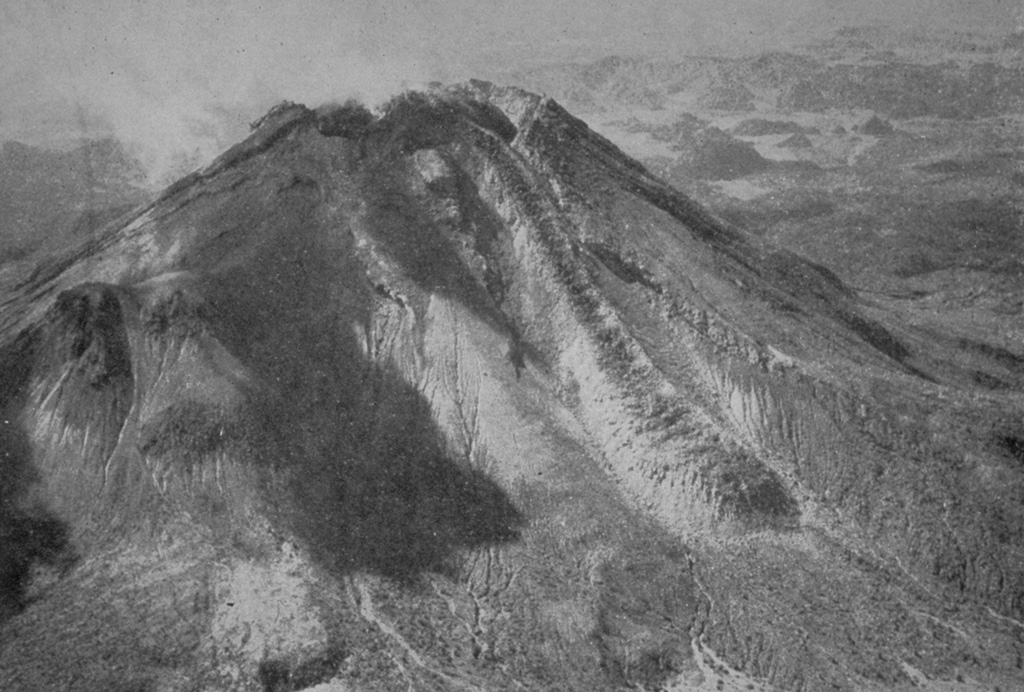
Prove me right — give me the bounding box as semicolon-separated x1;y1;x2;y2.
0;0;1024;178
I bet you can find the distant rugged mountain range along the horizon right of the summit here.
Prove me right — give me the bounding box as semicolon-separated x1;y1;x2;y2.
504;38;1024;119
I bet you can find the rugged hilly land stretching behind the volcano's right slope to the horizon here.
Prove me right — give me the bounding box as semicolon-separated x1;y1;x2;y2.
508;28;1024;378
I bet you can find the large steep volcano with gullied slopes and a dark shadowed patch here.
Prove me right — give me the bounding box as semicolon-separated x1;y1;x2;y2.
0;83;1024;691
